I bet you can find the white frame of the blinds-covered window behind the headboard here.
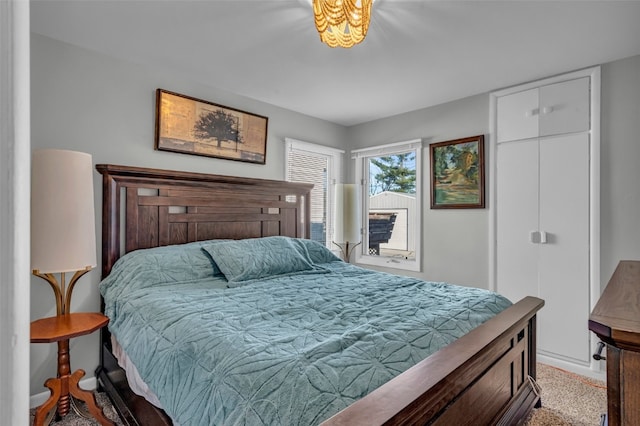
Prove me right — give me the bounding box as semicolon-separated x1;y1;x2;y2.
284;138;345;250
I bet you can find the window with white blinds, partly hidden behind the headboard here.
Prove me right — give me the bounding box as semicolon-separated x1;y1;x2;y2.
285;138;344;248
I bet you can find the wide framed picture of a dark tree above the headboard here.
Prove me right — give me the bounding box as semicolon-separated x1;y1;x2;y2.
155;89;268;164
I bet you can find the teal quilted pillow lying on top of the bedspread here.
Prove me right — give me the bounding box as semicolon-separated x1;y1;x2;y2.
202;236;324;287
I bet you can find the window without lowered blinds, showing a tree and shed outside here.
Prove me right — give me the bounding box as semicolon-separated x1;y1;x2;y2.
352;140;422;271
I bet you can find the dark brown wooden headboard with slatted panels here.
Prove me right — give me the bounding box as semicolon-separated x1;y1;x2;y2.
96;164;313;278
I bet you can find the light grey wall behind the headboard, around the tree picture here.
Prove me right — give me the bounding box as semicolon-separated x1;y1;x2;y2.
31;34;346;395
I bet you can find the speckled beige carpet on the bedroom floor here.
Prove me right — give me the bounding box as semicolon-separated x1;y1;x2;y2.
31;364;607;426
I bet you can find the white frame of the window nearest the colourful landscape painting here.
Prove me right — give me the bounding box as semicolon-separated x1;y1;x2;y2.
351;139;423;271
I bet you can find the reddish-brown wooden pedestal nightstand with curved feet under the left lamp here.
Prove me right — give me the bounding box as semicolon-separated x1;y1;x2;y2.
31;312;114;426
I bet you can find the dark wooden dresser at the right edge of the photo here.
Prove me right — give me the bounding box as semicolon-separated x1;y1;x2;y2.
589;260;640;426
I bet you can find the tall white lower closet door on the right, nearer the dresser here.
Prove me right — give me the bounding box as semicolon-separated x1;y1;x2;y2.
538;133;589;363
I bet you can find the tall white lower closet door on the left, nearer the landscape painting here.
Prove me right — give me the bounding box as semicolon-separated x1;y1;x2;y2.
496;139;539;303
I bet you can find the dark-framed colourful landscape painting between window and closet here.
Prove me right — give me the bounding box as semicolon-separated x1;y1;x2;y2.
429;135;485;209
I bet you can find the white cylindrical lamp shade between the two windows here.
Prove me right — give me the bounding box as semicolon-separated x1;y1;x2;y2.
333;183;362;244
